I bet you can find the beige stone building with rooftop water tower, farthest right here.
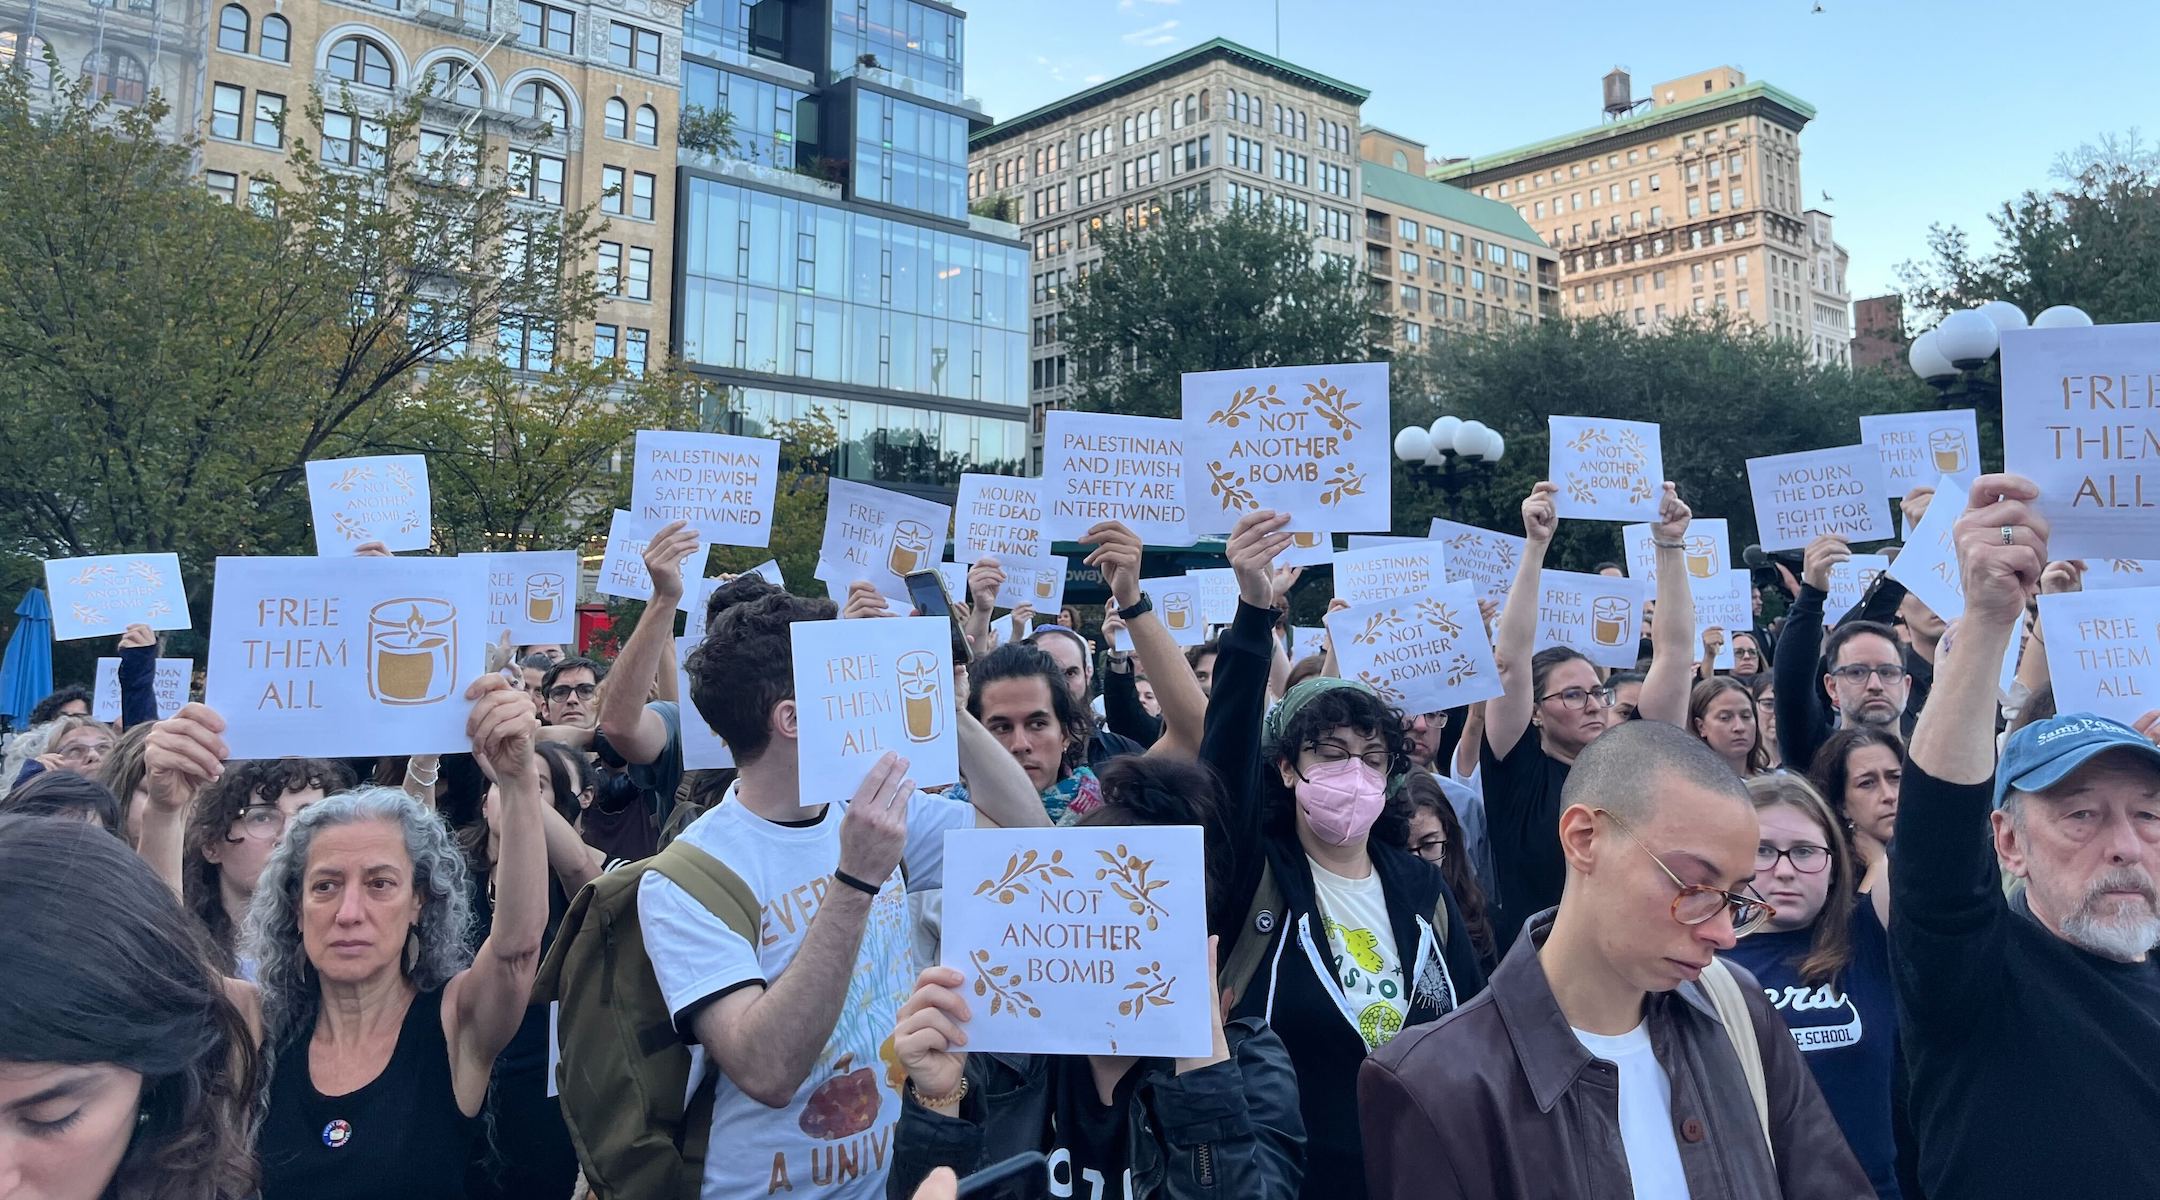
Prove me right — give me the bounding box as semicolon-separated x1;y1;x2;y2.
1432;67;1842;363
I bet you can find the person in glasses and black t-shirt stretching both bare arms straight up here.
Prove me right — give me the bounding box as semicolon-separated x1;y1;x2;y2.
1480;483;1696;945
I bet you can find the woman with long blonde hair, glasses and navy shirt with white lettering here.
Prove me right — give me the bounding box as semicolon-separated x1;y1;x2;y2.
1726;773;1903;1200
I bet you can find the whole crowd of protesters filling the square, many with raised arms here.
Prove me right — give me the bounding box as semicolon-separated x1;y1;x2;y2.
0;475;2160;1200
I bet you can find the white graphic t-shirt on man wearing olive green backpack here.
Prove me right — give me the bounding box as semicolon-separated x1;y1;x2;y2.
637;788;974;1200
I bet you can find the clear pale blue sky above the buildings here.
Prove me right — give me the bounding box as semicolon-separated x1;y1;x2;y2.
959;0;2160;308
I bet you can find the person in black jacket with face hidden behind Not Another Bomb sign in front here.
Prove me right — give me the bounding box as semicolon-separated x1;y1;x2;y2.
886;758;1305;1200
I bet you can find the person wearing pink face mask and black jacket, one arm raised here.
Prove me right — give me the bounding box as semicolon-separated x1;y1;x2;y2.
1201;512;1484;1200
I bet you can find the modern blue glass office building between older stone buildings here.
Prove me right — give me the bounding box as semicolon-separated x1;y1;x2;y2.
674;0;1028;494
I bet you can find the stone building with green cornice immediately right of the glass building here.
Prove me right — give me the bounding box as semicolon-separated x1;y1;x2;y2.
968;39;1367;468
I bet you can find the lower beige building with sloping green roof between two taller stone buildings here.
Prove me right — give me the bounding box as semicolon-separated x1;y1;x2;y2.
1359;127;1560;352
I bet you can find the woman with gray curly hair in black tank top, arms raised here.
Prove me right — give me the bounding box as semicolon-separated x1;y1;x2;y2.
147;676;549;1200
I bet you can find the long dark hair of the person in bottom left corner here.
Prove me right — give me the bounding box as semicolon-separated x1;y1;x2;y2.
0;816;259;1200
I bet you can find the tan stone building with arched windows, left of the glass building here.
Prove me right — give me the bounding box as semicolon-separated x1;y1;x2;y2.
201;0;683;371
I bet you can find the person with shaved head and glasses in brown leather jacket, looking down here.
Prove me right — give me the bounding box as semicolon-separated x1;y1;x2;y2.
1359;721;1875;1200
